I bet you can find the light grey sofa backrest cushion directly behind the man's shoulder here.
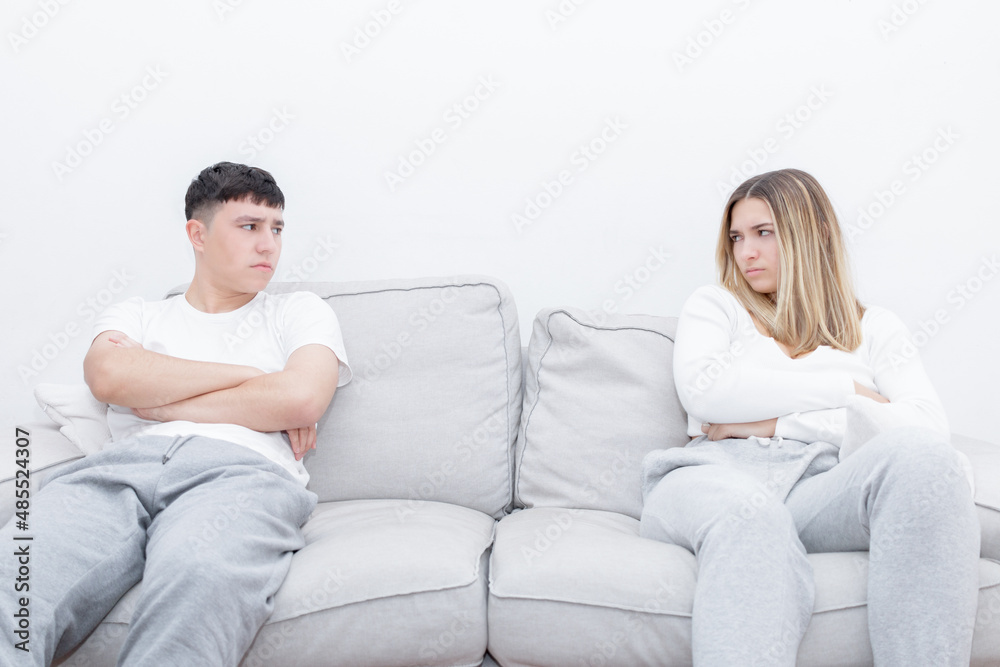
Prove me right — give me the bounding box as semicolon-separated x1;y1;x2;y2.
167;276;521;519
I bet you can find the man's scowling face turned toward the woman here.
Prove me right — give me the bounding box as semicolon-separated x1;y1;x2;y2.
196;200;285;293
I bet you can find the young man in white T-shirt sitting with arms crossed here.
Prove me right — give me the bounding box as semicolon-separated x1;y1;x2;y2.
0;162;351;666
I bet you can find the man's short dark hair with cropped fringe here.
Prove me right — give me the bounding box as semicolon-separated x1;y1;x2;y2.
184;162;285;224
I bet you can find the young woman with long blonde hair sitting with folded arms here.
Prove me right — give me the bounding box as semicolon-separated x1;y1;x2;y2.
640;169;980;667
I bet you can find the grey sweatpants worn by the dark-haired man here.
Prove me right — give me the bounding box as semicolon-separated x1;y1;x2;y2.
0;436;316;667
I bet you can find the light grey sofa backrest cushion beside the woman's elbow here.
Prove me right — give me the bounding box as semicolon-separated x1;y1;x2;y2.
514;308;688;519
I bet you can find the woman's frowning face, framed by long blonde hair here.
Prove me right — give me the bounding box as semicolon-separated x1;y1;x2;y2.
729;198;781;294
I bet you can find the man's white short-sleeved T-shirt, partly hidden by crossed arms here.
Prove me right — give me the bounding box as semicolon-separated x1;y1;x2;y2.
94;292;352;485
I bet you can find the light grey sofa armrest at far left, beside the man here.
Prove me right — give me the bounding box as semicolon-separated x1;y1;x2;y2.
0;423;83;526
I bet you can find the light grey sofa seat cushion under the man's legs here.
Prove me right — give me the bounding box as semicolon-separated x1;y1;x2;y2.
55;500;496;667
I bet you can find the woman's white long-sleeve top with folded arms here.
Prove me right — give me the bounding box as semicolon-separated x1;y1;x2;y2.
673;285;949;447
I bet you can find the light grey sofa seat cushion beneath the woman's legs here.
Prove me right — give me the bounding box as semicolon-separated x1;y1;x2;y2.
488;507;1000;667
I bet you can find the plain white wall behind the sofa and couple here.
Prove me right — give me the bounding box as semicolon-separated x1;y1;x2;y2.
0;0;1000;441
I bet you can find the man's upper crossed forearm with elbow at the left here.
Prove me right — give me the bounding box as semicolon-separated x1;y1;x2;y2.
84;341;263;408
